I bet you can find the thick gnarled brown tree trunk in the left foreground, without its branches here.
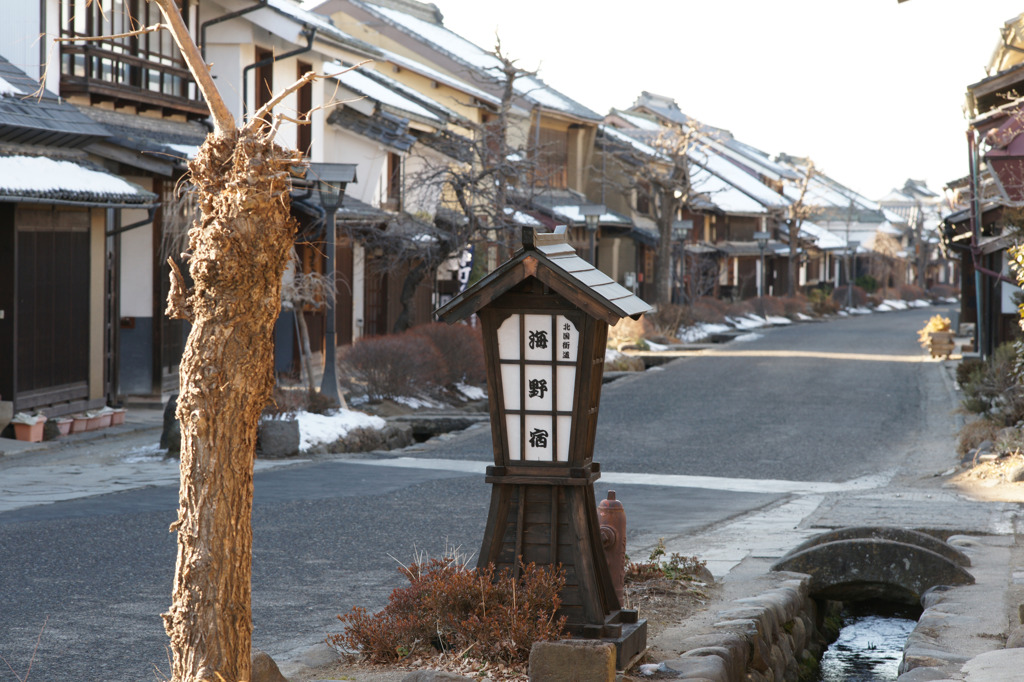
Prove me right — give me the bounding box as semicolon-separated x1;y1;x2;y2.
164;124;295;682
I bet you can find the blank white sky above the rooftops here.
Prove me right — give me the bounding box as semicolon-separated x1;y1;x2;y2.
432;0;1024;199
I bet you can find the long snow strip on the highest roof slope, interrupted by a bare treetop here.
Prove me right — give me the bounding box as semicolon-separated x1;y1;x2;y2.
359;2;603;120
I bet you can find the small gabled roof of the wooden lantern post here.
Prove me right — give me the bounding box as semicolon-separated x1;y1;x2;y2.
435;225;651;325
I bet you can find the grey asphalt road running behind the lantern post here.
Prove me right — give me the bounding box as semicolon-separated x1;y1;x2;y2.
0;309;950;682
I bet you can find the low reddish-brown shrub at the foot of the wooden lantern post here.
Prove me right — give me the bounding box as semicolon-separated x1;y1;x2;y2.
328;556;565;664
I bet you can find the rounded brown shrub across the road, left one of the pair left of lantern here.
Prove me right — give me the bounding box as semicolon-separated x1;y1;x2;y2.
341;334;446;401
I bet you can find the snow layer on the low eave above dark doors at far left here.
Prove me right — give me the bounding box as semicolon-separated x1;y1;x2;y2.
0;156;153;203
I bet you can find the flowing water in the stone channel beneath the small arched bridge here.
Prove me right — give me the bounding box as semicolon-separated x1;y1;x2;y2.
818;604;921;682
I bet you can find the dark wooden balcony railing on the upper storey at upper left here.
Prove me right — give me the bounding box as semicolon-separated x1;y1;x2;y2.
60;45;208;118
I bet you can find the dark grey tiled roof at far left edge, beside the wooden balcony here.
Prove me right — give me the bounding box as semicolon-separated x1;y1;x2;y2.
0;56;110;146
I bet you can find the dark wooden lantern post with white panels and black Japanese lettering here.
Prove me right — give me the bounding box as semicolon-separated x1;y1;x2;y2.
437;227;650;667
